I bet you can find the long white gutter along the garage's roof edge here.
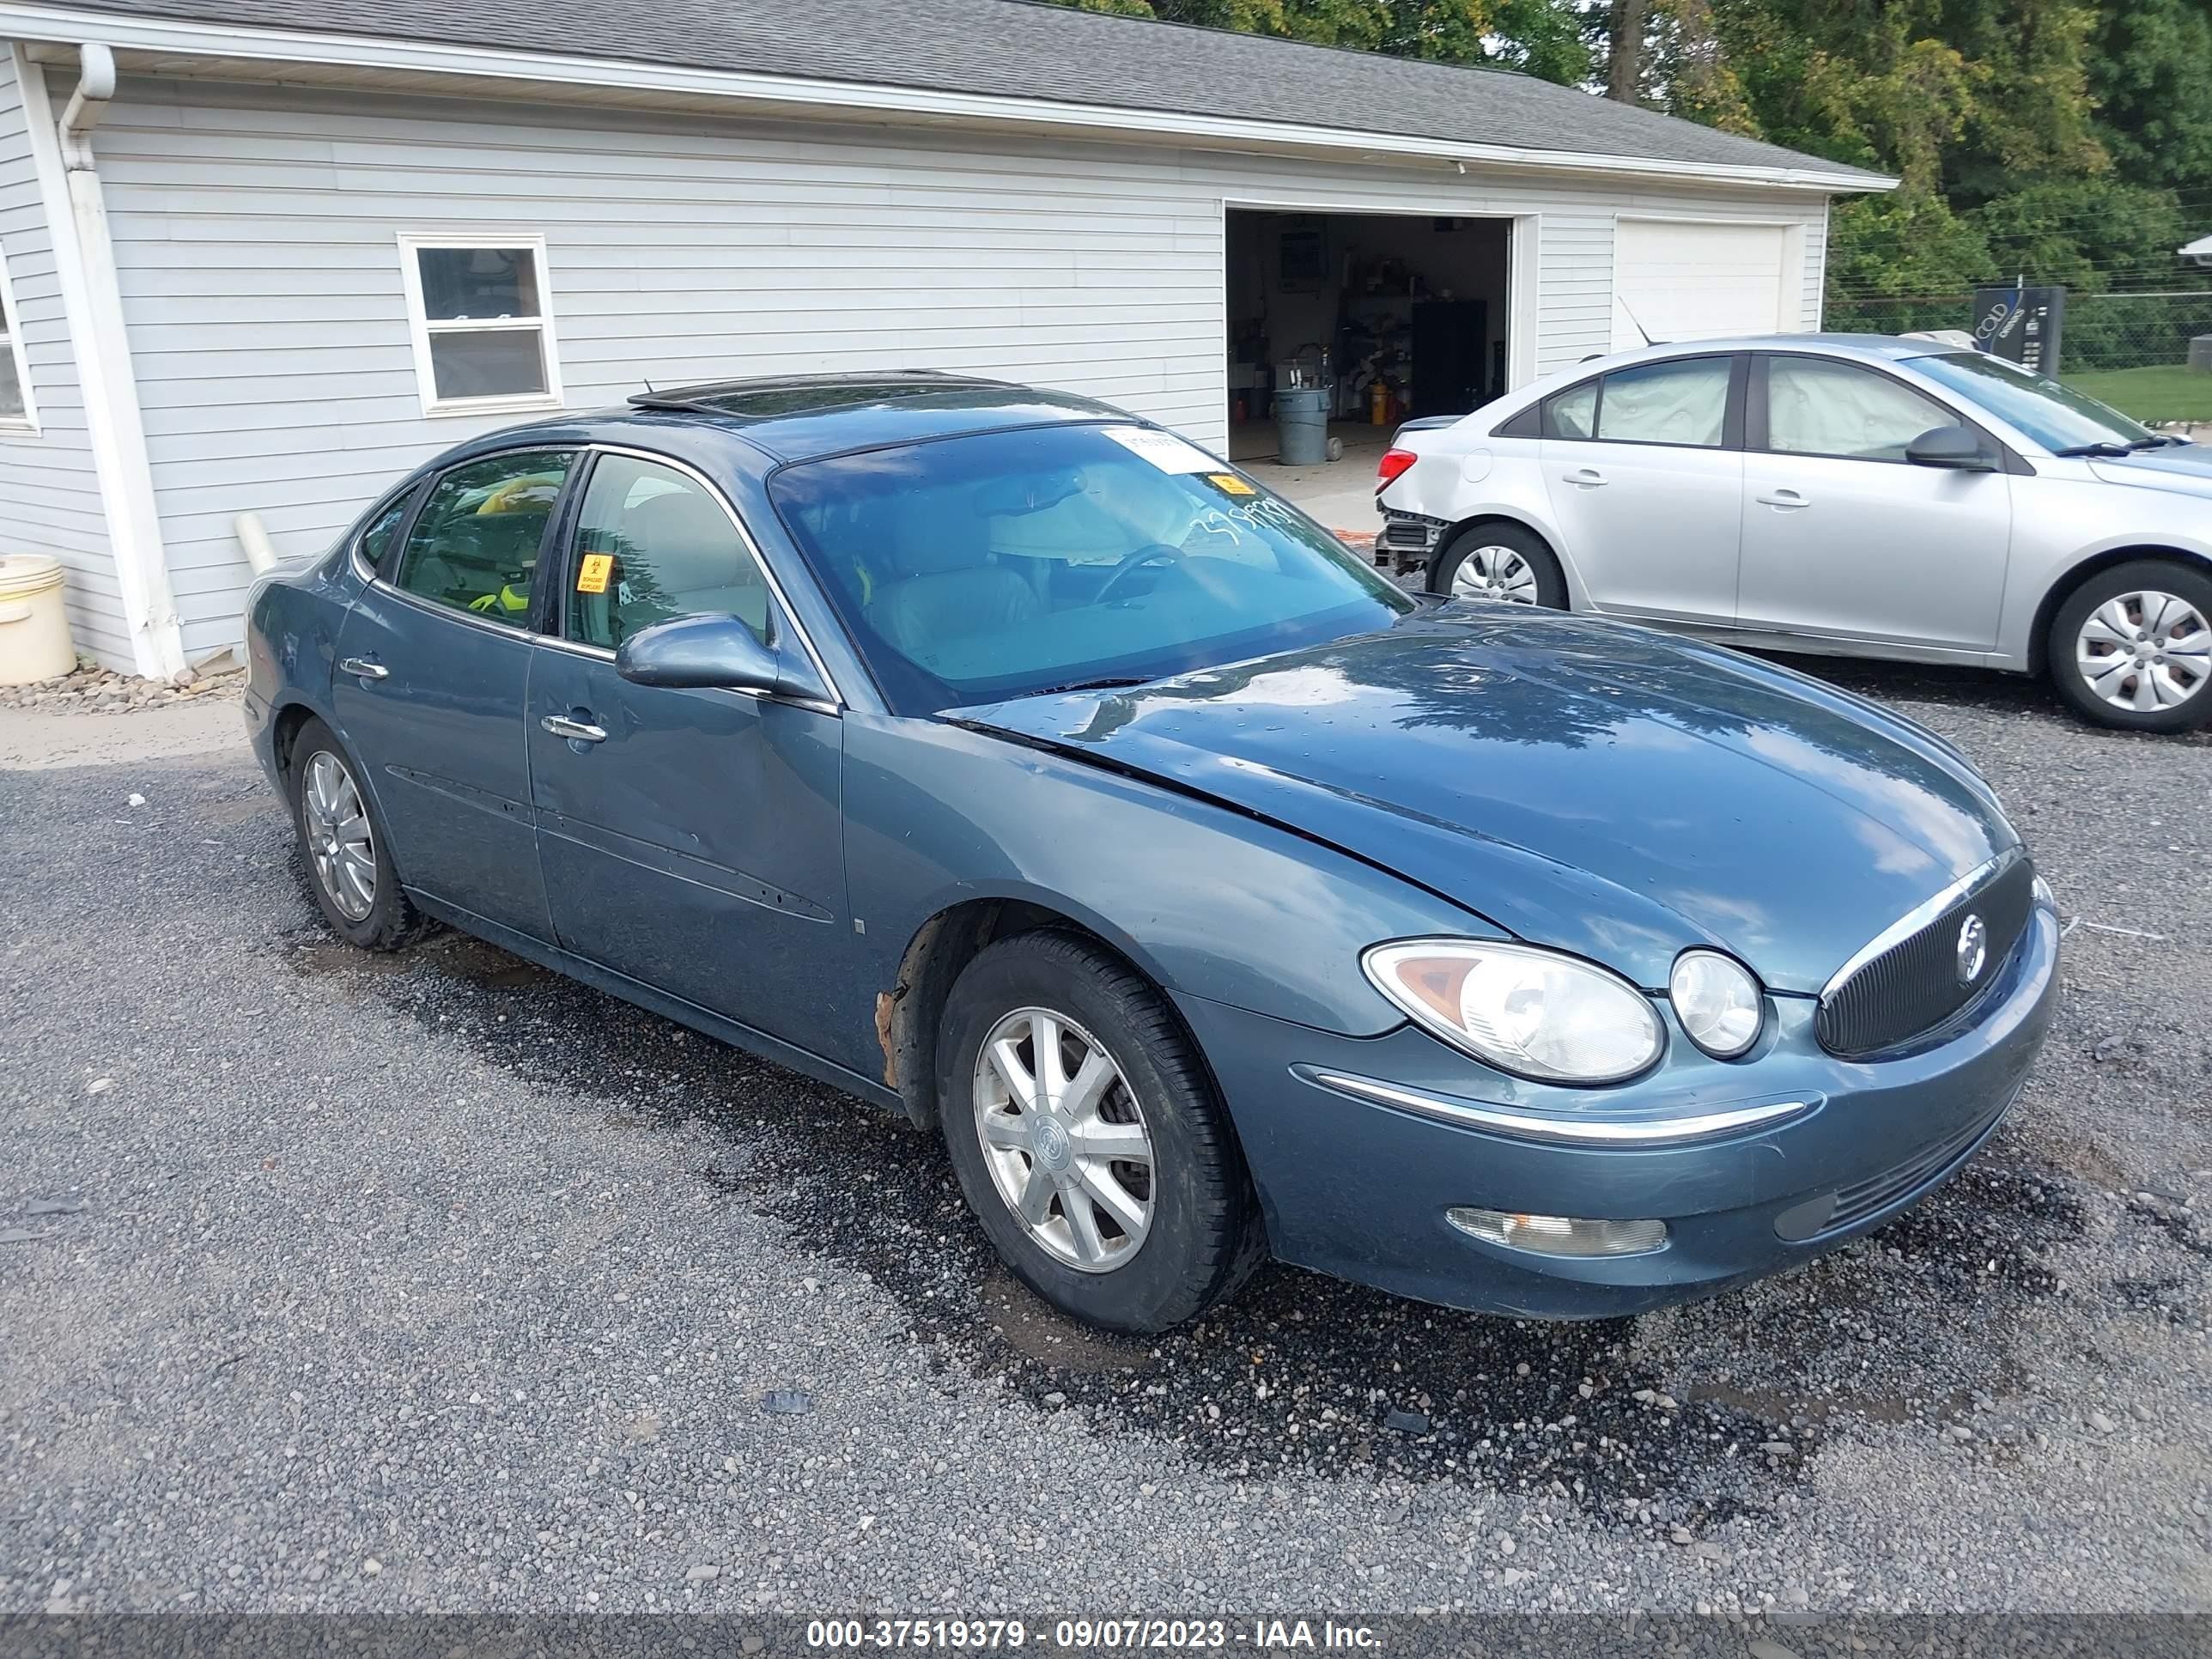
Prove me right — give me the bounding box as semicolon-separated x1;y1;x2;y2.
0;0;1898;192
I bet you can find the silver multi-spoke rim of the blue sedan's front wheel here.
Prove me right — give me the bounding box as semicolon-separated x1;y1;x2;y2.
975;1009;1152;1274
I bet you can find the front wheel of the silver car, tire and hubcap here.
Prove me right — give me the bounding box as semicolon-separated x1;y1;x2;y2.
2044;560;2212;732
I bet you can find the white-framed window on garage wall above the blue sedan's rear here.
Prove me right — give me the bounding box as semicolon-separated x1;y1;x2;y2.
400;237;560;414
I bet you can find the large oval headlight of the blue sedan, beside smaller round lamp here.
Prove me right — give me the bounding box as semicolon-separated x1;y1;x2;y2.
1360;938;1666;1084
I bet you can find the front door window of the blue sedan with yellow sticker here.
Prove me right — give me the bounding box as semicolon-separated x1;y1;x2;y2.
566;456;768;648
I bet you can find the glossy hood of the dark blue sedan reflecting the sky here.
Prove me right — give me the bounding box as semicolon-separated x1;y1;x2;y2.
947;619;2017;994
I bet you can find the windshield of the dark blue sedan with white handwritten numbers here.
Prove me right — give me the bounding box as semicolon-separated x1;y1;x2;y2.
769;425;1413;714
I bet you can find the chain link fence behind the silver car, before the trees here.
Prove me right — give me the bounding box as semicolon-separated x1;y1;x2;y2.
1825;288;2212;422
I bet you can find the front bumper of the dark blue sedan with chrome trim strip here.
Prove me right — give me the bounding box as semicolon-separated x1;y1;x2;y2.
1179;905;2059;1318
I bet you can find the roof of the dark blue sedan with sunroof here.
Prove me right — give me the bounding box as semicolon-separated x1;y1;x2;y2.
586;369;1133;460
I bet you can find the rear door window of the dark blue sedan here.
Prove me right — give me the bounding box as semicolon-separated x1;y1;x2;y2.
394;449;575;629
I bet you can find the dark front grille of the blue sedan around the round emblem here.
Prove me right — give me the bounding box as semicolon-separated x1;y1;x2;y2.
1814;852;2035;1060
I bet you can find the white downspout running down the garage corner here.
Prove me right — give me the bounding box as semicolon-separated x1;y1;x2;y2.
13;45;184;679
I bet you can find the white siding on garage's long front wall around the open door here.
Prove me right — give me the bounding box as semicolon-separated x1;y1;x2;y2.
77;82;1820;654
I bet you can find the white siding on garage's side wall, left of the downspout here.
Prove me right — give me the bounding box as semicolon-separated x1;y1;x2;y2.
0;42;131;668
